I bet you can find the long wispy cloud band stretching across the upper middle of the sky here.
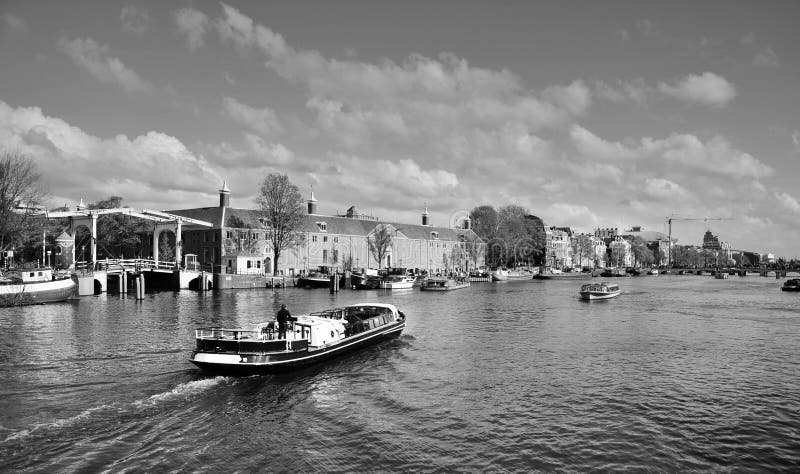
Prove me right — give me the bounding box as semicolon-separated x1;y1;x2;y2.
214;4;590;137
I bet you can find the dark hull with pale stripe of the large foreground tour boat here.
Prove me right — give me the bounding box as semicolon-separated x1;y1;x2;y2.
189;321;406;375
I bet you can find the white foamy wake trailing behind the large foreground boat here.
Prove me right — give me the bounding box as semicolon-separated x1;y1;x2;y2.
0;377;235;448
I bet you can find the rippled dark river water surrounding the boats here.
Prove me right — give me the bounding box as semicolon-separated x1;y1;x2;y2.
0;275;800;472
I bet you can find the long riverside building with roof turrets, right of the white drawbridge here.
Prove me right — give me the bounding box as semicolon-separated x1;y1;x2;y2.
169;185;486;276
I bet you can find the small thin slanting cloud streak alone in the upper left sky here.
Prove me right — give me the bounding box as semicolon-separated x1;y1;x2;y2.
58;37;153;92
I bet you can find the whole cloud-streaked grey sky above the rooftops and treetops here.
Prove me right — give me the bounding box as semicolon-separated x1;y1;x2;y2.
0;0;800;258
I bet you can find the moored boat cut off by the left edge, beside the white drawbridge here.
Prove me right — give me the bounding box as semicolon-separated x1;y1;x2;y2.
0;268;78;306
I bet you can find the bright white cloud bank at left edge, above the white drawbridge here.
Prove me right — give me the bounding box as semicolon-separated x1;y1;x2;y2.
0;101;221;204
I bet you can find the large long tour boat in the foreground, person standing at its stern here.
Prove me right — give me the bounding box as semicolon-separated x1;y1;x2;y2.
189;303;406;375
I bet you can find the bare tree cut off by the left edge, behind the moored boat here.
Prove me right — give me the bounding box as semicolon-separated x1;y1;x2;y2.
0;152;45;251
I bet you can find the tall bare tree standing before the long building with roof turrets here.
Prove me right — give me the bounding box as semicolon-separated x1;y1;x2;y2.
256;173;304;273
